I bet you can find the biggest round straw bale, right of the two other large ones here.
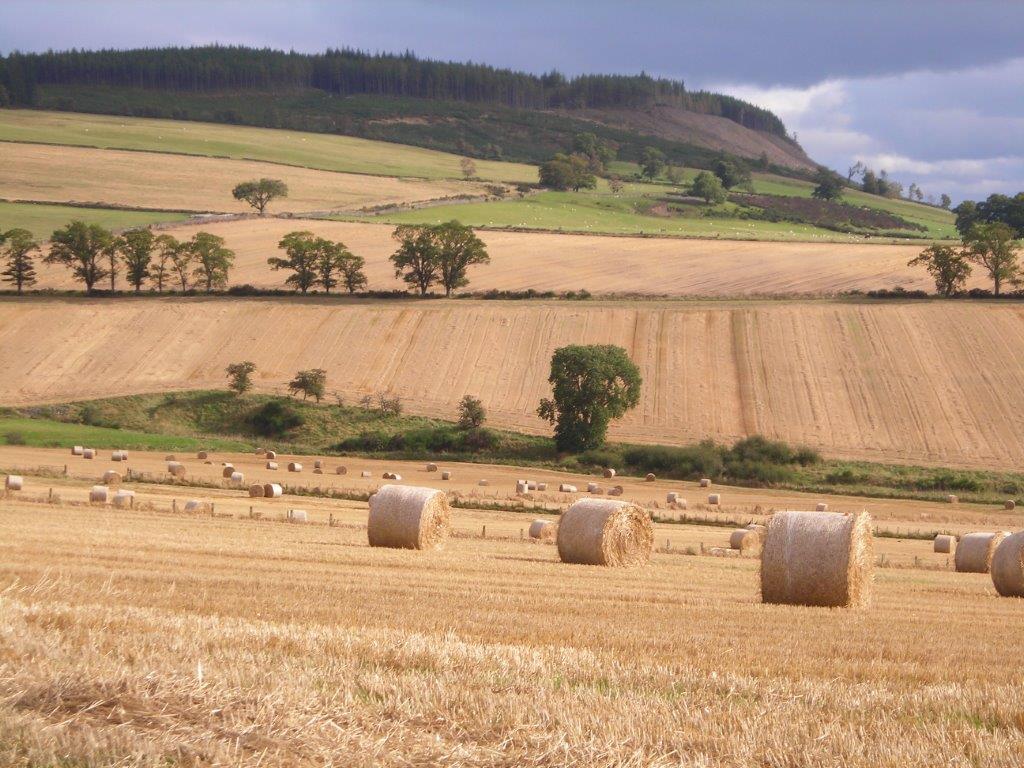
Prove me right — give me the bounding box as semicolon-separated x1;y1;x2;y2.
761;512;874;607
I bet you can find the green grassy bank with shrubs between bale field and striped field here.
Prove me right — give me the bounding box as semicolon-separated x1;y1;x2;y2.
0;391;1024;504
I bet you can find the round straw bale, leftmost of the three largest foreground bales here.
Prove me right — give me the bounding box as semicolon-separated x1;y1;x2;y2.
367;485;451;549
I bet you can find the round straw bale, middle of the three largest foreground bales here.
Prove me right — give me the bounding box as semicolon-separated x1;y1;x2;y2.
557;499;654;565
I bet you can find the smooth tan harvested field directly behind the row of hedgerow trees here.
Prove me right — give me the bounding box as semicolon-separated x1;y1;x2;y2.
28;219;970;296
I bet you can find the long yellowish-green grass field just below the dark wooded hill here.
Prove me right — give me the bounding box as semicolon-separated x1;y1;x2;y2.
0;110;537;182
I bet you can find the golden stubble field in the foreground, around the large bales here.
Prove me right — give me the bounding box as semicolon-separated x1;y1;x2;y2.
0;449;1024;768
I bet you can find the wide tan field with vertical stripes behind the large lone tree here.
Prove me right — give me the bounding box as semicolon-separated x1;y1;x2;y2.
0;297;1024;469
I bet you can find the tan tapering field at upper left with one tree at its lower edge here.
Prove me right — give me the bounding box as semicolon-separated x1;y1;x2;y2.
0;143;491;215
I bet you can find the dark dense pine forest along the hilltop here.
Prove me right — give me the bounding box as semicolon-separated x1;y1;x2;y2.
0;46;785;136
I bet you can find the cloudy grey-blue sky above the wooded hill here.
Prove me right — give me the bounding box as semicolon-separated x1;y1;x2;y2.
0;0;1024;200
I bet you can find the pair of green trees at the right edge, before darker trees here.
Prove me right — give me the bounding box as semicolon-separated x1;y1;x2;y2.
908;222;1024;297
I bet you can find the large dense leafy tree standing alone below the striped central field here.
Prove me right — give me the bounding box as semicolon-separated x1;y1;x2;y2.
537;344;642;452
